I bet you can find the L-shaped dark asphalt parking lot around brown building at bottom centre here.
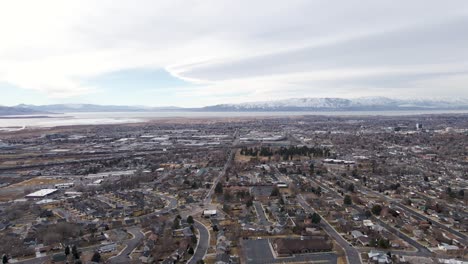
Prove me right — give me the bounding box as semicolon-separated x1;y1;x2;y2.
242;239;338;264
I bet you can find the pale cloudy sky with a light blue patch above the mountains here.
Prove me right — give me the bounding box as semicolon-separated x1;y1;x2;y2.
0;0;468;107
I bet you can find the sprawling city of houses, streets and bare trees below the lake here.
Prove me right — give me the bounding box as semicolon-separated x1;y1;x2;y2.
0;115;468;264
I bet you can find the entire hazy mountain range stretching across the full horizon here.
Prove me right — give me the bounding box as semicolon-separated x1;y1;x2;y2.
0;97;468;115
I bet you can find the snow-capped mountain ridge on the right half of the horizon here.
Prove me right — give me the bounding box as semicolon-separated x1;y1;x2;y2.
203;97;468;111
